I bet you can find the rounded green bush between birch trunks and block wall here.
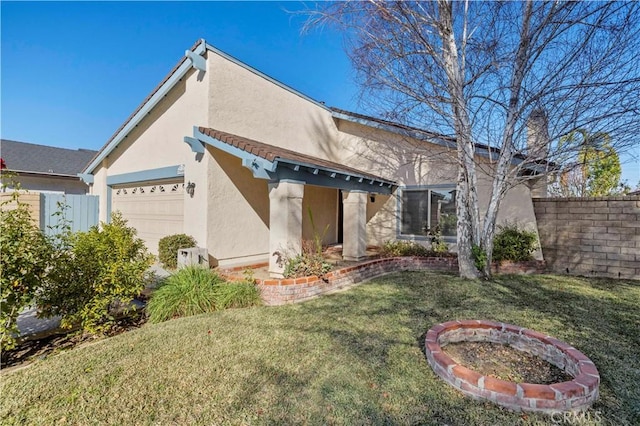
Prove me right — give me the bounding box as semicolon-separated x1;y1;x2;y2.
493;224;538;262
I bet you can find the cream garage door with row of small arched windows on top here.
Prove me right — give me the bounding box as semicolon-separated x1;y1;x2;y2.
111;180;184;254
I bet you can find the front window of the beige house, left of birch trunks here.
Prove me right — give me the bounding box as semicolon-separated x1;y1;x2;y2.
400;186;457;238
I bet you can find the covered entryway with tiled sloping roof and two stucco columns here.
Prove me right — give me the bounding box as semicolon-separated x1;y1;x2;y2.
184;127;397;277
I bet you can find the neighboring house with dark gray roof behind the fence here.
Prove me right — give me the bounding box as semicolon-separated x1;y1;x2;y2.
0;139;97;194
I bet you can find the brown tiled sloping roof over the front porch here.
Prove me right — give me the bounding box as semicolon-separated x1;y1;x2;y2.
198;127;395;185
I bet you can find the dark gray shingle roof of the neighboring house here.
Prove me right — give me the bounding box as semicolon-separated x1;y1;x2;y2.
0;139;97;178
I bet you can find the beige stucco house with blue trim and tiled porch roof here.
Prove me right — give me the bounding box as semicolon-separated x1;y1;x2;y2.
82;40;536;276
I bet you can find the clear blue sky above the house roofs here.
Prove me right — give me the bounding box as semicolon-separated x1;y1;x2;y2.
0;1;640;186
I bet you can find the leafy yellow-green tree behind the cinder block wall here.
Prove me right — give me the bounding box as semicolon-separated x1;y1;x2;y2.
550;129;628;197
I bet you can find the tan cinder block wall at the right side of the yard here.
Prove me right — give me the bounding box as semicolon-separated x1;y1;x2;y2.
533;196;640;280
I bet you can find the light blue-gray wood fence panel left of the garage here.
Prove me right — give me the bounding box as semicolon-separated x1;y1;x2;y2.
40;193;99;235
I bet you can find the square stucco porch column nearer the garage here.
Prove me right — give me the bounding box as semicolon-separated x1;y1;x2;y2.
269;180;304;278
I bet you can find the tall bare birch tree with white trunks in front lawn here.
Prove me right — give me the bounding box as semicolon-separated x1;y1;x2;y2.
308;0;640;278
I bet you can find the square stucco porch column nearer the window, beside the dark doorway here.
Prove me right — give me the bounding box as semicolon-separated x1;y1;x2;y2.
342;191;367;260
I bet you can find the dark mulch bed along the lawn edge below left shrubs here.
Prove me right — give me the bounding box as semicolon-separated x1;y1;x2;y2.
0;314;147;371
